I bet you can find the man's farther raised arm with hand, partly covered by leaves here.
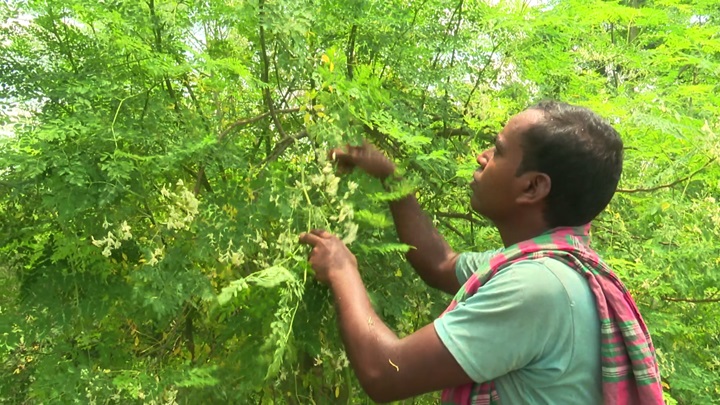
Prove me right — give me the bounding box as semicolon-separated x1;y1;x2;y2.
331;144;460;294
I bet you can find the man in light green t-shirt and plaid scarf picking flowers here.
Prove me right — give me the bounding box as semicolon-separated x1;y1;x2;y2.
300;102;662;404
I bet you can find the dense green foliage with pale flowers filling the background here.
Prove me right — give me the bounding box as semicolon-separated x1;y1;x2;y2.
0;0;720;404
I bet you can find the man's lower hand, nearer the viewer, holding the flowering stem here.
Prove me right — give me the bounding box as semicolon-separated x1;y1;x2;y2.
300;229;357;284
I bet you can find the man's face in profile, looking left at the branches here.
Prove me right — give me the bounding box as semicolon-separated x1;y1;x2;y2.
470;110;543;223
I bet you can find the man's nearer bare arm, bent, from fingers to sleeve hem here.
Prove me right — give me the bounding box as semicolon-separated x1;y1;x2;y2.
300;230;471;402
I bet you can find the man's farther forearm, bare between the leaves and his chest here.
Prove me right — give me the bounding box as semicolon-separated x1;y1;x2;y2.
390;195;460;294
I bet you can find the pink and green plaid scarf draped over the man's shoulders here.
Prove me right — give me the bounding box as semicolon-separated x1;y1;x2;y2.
442;224;663;405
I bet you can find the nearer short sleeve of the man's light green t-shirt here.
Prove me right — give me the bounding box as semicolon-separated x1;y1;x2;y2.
434;261;571;383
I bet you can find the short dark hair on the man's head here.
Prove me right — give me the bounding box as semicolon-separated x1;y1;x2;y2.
518;101;623;227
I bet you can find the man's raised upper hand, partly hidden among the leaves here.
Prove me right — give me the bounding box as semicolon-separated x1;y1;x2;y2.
330;142;395;180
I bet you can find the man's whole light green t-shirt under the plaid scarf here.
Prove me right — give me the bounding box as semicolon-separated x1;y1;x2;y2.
434;251;602;405
